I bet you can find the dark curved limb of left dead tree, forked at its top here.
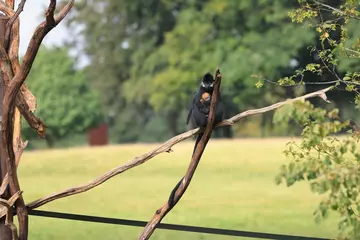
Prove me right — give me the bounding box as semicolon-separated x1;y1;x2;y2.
0;0;74;240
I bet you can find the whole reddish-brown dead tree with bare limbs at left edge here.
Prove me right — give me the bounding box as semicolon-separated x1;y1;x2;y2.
0;0;74;240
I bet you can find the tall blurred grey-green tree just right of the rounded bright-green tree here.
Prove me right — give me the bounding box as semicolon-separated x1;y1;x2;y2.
65;0;183;142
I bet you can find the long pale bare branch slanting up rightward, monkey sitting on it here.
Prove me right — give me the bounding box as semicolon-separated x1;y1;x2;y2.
27;87;331;209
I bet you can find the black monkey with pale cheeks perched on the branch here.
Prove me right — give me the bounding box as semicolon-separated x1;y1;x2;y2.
186;73;224;127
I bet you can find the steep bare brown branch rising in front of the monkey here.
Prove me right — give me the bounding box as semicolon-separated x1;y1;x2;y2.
139;69;221;240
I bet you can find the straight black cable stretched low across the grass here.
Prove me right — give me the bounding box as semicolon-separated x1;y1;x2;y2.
28;210;330;240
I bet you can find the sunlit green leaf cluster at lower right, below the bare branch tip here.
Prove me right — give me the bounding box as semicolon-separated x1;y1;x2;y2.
274;101;360;239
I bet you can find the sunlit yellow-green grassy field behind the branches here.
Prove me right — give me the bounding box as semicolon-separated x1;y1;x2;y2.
19;139;337;240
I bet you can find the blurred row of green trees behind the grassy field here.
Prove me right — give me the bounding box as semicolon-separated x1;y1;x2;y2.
27;0;360;144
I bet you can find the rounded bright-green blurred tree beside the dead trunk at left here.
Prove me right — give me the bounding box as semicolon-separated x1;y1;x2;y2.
23;47;103;147
